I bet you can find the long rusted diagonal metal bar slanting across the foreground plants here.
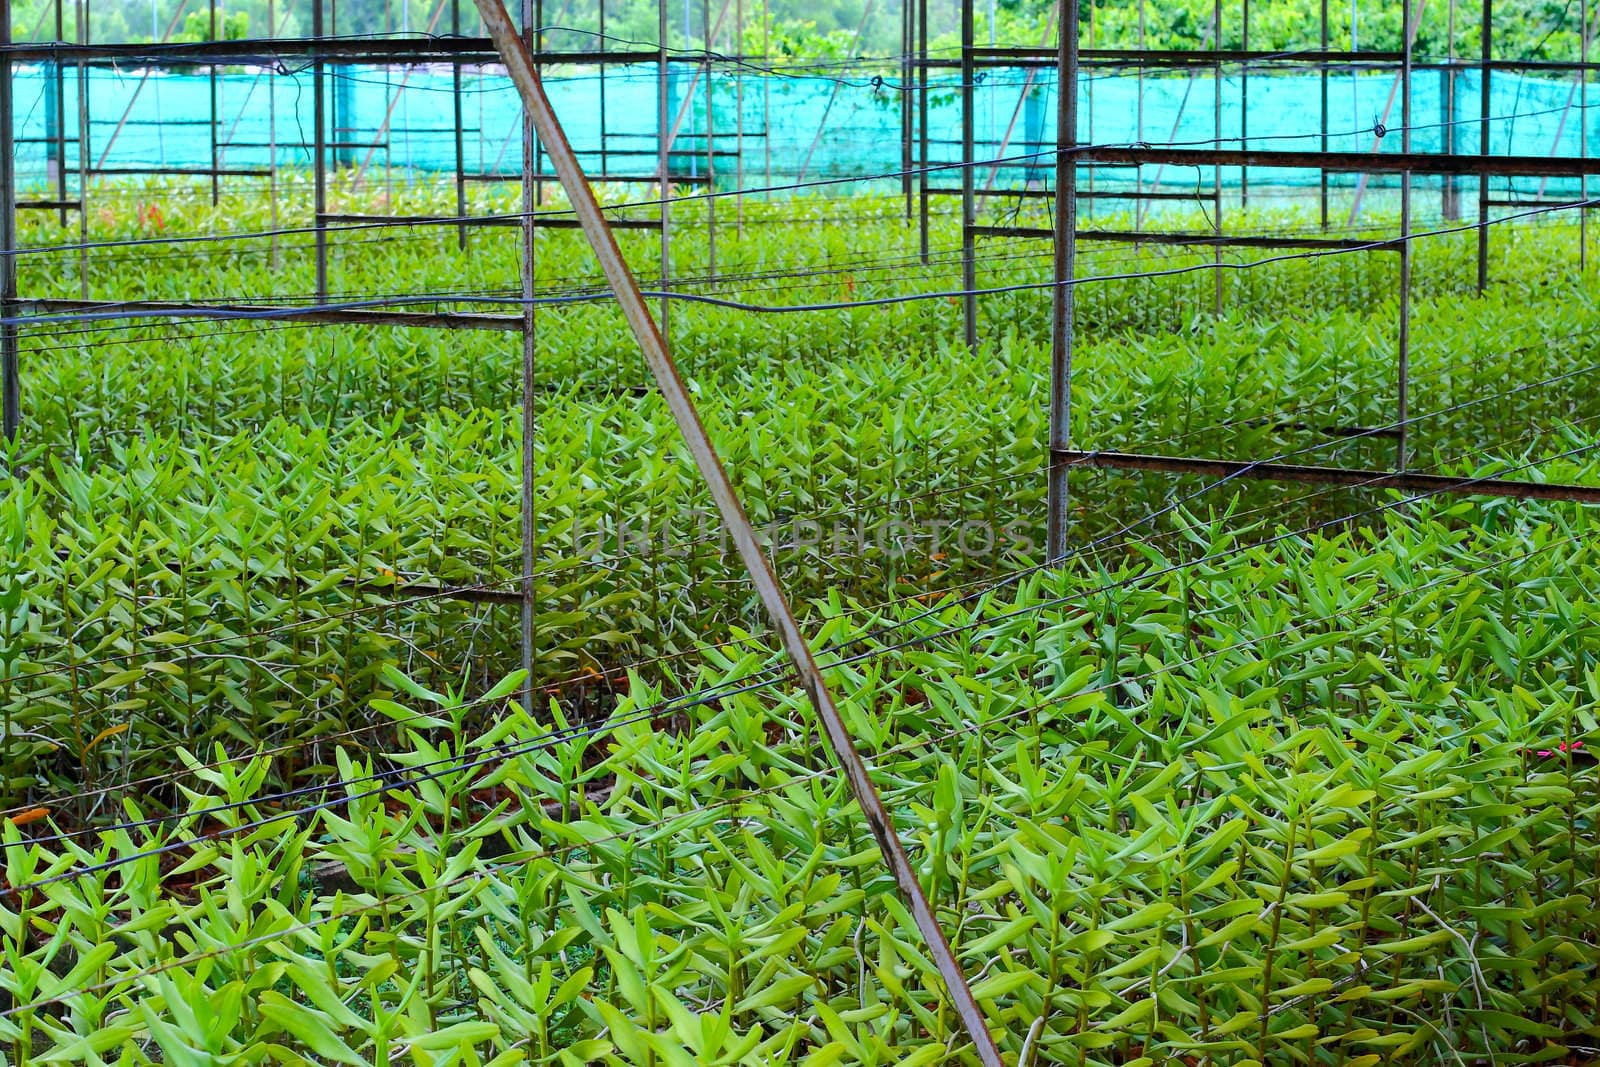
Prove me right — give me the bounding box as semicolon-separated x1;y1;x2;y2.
474;0;1002;1067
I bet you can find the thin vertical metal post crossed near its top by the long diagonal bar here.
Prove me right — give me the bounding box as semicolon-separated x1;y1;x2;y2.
522;0;540;718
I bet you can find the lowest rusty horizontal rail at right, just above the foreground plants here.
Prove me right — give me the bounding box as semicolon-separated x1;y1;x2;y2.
1053;450;1600;504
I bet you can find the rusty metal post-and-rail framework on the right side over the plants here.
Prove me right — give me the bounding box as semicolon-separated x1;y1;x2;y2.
934;0;1600;561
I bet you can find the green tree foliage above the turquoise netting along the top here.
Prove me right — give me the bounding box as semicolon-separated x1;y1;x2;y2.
11;0;1581;59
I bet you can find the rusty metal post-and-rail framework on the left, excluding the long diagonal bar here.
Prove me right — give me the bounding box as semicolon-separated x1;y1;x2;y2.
0;0;732;751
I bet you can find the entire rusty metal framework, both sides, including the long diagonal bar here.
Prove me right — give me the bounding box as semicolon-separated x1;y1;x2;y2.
0;0;1600;1065
